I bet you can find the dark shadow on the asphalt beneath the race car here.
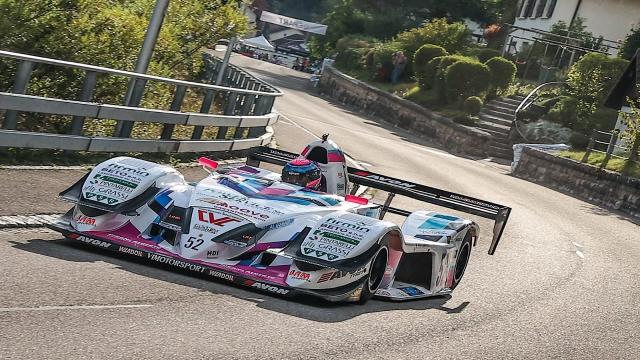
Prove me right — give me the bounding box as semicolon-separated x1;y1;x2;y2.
10;239;469;323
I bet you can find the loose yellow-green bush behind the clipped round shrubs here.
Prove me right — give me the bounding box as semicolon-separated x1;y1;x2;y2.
396;19;471;58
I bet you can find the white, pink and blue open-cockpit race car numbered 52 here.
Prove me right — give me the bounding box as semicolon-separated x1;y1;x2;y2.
49;136;511;303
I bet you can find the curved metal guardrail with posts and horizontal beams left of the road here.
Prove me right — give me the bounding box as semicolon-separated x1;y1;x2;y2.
0;51;282;152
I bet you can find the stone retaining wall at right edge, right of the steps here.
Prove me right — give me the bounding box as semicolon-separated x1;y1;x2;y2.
514;148;640;217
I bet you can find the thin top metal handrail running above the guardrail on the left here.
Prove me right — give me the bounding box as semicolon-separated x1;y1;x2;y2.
0;50;284;96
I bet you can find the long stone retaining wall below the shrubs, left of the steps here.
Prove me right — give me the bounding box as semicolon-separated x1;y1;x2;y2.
320;67;491;157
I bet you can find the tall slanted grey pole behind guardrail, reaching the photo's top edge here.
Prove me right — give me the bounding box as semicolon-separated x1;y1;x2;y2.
115;0;169;138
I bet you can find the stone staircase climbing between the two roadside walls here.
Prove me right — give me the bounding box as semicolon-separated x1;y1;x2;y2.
476;96;524;160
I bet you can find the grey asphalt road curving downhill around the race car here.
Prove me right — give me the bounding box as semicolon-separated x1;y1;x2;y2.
0;57;640;359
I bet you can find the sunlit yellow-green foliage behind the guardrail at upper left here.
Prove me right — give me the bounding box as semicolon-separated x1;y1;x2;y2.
0;0;247;104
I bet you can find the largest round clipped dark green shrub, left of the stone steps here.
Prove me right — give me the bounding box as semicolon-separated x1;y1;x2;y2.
445;60;491;102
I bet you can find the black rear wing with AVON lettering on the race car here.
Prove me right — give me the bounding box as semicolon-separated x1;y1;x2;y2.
247;146;511;255
